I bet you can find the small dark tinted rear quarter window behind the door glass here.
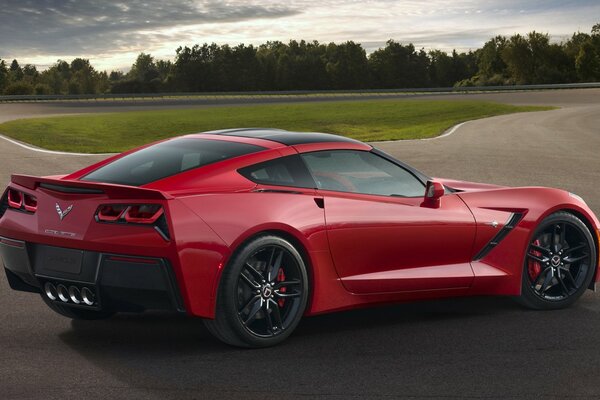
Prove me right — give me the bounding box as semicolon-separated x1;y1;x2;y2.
238;155;316;188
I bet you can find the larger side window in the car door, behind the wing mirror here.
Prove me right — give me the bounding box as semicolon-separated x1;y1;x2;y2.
301;150;425;197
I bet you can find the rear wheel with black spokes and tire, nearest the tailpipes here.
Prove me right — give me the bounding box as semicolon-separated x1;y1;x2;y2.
204;235;309;348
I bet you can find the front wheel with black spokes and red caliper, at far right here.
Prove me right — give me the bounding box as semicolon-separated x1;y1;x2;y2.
517;211;597;310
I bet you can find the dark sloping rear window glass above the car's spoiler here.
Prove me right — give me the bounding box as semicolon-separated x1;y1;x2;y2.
81;138;264;186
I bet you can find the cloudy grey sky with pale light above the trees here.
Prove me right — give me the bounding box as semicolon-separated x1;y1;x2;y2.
0;0;600;71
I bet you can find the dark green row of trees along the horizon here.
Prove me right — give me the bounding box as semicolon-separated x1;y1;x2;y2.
0;24;600;95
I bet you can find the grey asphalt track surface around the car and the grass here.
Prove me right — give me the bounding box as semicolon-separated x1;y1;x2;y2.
0;89;600;399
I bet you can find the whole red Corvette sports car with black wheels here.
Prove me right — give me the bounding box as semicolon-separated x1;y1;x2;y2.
0;129;600;347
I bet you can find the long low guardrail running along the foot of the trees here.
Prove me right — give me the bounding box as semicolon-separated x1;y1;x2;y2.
0;82;600;102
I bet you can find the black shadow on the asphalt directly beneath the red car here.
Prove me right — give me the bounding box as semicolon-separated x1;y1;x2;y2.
61;297;522;354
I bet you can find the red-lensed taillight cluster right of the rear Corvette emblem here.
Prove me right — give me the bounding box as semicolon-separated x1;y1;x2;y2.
96;204;170;240
